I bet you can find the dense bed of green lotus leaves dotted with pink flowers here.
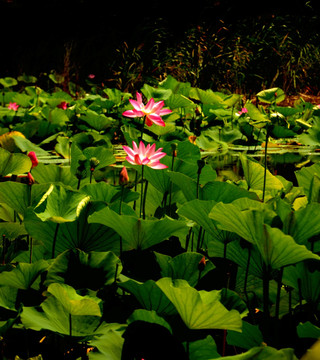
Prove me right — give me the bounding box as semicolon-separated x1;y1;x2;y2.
0;74;320;360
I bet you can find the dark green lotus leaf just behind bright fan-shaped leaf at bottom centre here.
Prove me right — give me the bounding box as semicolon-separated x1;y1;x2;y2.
155;252;215;286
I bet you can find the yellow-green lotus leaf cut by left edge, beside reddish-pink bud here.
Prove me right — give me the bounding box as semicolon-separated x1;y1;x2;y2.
0;147;31;176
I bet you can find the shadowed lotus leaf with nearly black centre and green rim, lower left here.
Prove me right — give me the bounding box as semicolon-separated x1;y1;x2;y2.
45;249;122;290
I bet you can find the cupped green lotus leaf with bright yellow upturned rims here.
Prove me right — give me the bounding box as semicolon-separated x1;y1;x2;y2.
34;184;90;223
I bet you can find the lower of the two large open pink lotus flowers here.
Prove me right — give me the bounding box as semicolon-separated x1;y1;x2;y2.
122;141;168;169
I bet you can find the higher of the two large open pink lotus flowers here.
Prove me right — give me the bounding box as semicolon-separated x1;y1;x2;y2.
122;92;172;126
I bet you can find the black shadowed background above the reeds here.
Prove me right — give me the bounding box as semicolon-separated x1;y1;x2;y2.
0;0;320;83
